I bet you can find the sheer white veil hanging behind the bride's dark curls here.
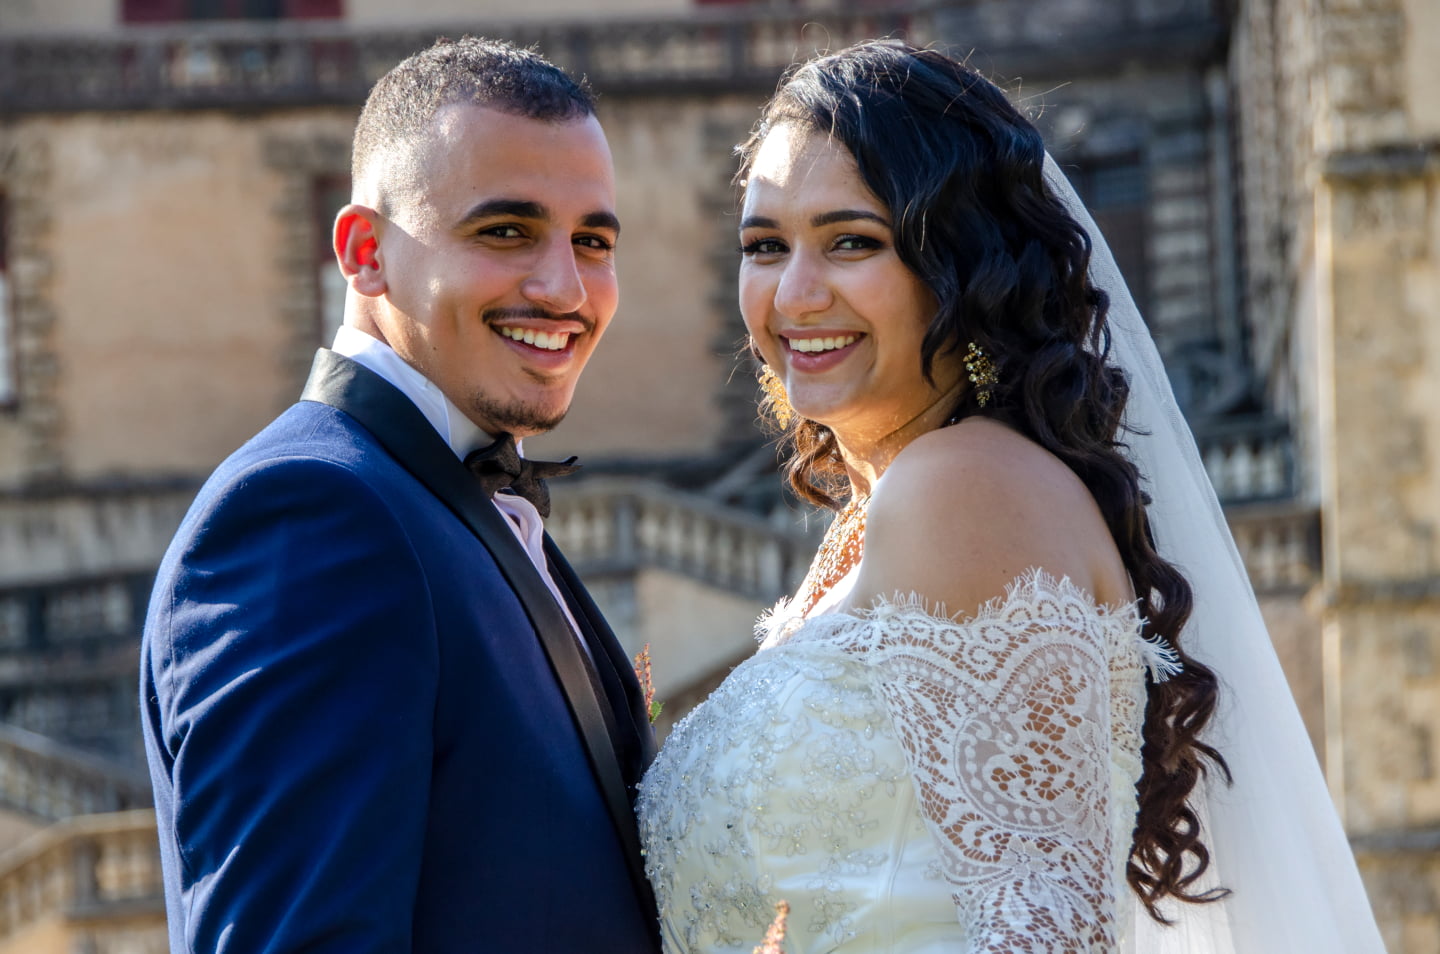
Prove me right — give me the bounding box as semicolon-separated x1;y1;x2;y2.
1045;156;1385;954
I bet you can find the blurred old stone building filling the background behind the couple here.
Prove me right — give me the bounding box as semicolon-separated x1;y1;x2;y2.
0;0;1440;954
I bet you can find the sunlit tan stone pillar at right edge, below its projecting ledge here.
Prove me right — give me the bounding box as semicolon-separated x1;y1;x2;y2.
1316;160;1440;953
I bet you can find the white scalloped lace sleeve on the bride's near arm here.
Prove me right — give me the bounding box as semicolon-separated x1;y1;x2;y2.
840;574;1135;954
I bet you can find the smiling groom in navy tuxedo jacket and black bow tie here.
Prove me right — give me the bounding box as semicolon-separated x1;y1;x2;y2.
141;39;658;954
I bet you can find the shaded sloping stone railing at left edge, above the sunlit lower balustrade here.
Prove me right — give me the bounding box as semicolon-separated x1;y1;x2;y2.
0;723;151;821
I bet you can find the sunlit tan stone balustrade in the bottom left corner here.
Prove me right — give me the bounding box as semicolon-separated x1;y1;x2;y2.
0;810;164;950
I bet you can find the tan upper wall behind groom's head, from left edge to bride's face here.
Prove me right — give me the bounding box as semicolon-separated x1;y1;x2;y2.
0;97;755;486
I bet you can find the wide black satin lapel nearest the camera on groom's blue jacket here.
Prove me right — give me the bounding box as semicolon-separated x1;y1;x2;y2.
301;349;648;891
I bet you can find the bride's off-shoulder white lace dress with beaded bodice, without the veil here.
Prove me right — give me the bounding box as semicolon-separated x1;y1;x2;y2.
639;572;1155;954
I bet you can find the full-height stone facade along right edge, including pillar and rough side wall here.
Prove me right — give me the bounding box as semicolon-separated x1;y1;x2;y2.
1231;0;1440;953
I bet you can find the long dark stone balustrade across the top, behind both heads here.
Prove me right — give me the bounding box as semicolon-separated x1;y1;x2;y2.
0;0;1221;112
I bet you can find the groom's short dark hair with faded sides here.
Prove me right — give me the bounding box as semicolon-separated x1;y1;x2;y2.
350;36;595;212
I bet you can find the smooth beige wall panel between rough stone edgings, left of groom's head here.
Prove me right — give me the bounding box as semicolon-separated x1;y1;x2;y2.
45;114;298;481
